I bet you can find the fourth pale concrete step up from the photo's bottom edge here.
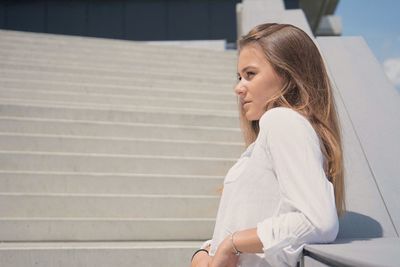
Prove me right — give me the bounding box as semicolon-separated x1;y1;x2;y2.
0;171;223;196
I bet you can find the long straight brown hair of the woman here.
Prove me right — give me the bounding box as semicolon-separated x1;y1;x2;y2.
238;23;346;216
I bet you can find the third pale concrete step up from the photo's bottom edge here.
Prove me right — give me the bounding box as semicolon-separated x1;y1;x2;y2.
0;193;219;219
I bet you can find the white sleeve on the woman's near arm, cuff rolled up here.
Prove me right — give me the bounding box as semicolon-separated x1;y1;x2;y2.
257;108;339;266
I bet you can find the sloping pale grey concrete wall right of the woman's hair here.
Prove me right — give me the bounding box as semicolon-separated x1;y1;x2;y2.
318;37;400;239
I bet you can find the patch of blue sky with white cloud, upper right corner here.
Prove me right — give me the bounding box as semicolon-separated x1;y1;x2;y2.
335;0;400;93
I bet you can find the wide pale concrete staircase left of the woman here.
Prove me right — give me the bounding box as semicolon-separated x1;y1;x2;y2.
0;30;244;267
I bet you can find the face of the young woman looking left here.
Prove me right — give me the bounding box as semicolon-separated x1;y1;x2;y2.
235;45;282;121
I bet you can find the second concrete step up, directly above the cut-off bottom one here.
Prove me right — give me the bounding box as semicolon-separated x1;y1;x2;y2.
0;217;215;242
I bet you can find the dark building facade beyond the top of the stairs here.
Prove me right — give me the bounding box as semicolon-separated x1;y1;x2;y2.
0;0;299;43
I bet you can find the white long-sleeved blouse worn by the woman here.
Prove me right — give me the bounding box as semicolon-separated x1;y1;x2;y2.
203;107;339;267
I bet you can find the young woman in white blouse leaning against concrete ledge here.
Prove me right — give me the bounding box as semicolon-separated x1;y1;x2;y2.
192;24;345;267
